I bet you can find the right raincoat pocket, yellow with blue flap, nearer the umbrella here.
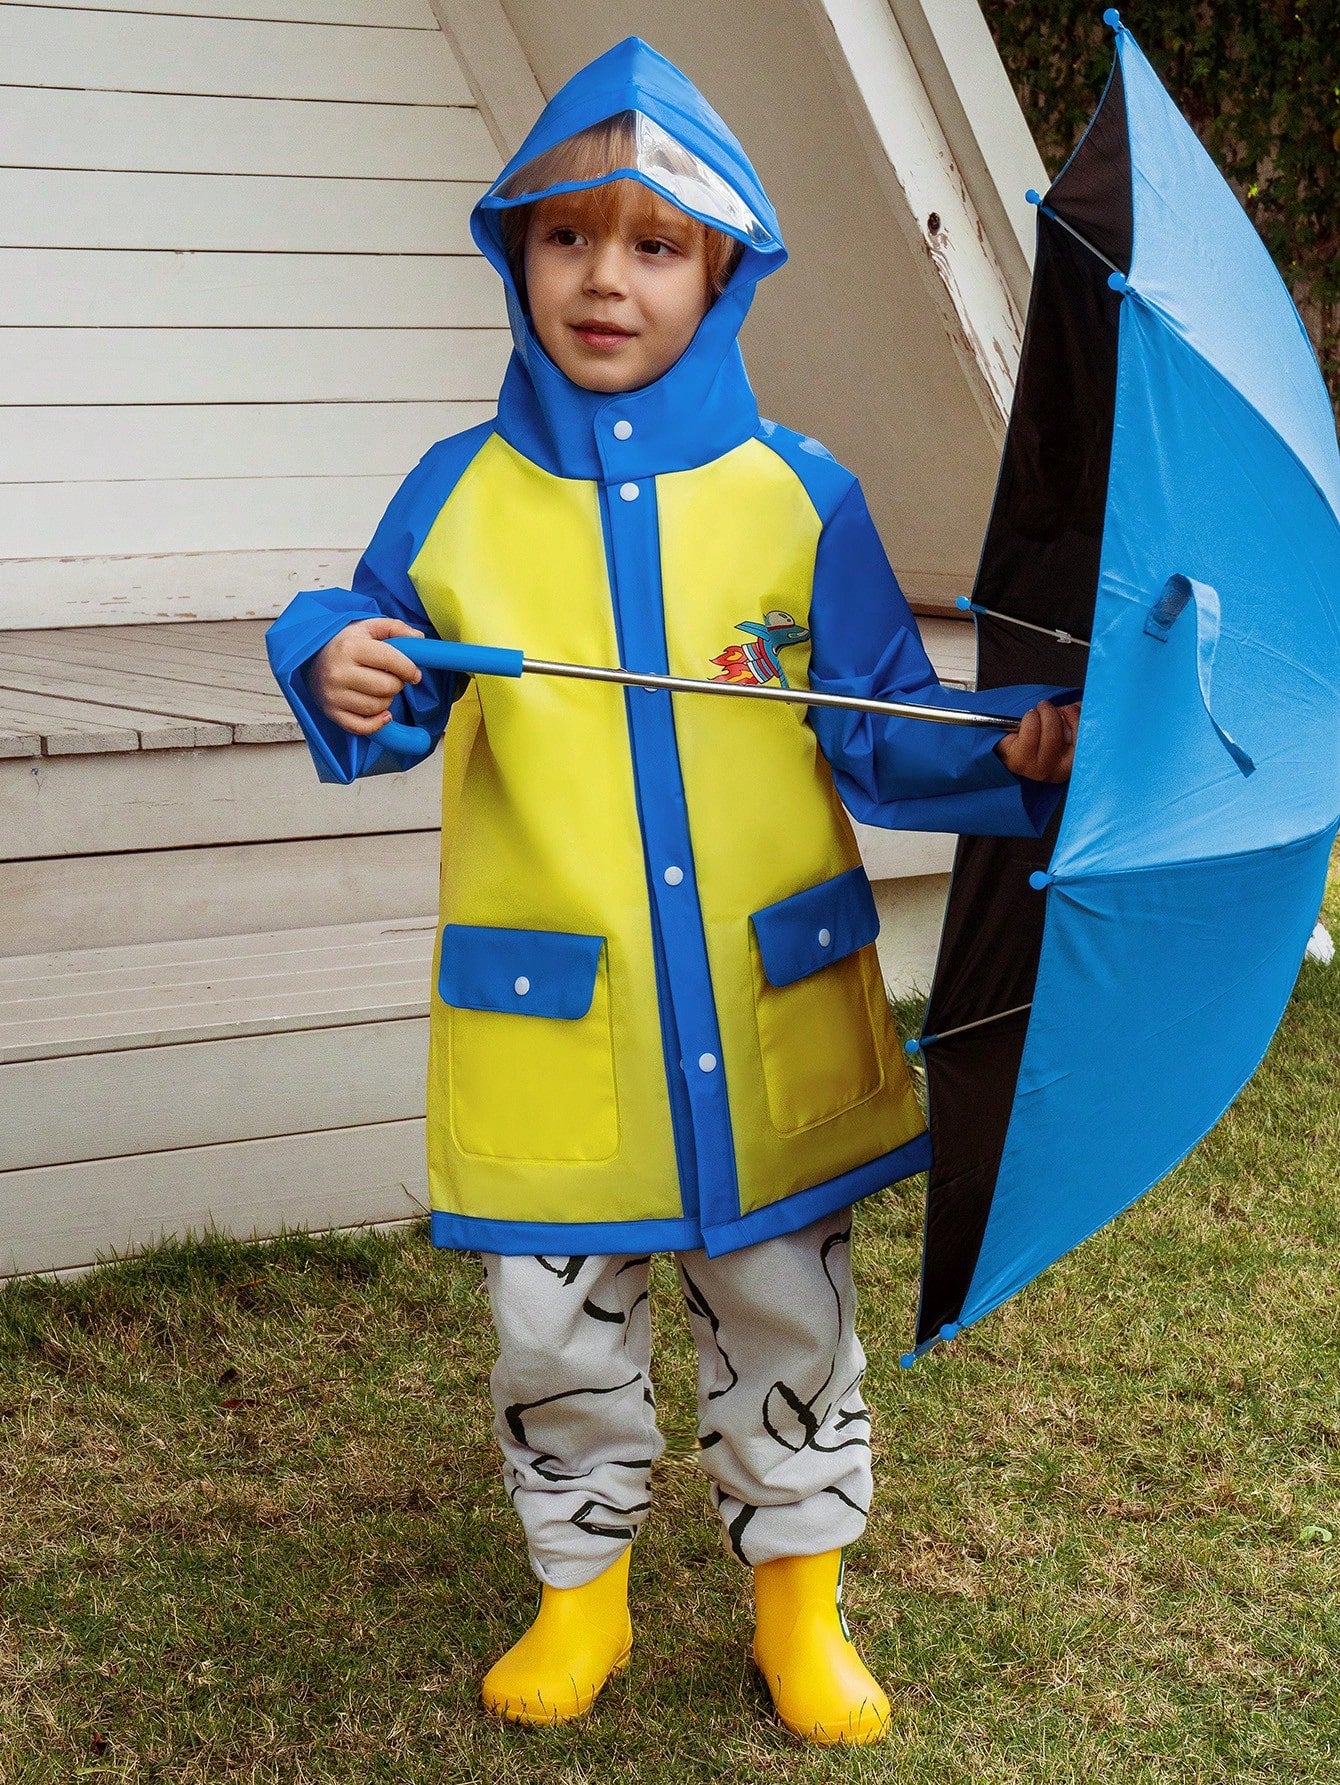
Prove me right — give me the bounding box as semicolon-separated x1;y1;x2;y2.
749;868;885;1133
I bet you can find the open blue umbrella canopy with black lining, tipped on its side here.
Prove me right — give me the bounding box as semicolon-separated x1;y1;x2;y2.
905;11;1340;1362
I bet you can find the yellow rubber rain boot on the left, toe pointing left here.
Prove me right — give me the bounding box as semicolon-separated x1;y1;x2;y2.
480;1544;633;1723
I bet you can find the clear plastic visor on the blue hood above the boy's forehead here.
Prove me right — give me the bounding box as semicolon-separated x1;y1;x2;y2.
480;111;776;248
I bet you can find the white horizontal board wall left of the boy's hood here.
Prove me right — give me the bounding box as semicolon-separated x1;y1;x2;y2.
0;0;510;625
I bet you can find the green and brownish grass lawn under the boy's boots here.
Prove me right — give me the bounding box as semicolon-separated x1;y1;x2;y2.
0;871;1340;1785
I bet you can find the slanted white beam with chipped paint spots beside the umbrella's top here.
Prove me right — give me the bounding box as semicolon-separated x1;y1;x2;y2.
805;0;1024;443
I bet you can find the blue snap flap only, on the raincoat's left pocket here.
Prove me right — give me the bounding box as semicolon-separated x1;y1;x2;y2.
437;923;605;1017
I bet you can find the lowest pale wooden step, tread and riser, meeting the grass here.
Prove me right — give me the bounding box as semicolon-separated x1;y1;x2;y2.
0;917;437;1274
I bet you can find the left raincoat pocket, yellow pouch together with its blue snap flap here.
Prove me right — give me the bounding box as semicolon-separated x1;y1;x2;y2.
437;923;619;1164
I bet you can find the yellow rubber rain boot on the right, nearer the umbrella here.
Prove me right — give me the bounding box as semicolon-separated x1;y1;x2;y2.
753;1549;890;1748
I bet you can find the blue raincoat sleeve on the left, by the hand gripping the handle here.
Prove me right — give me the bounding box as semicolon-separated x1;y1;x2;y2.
266;452;464;782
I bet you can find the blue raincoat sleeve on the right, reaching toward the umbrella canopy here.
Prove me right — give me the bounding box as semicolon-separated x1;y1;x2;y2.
810;480;1072;837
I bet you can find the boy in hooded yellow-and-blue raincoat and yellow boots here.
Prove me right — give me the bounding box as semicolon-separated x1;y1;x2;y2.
269;37;1078;1742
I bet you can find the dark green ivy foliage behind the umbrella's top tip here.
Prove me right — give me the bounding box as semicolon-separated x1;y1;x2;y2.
983;0;1340;412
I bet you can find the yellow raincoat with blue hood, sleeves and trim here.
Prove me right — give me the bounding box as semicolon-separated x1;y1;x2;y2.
268;37;1056;1253
